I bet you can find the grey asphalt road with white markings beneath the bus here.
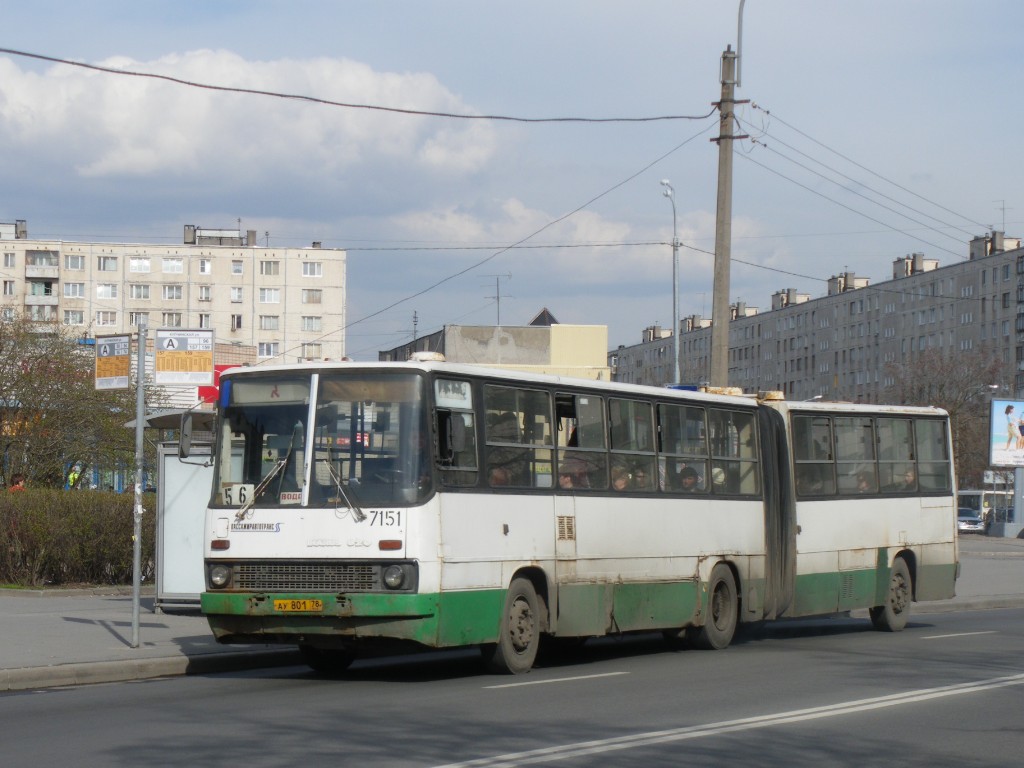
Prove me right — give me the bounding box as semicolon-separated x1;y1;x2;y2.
0;609;1024;768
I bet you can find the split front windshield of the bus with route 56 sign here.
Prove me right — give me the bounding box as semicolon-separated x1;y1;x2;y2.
212;372;432;507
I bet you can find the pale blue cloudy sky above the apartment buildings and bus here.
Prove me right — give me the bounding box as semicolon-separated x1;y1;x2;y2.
0;0;1024;359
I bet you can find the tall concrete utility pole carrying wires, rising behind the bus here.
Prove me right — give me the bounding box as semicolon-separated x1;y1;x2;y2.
709;17;748;387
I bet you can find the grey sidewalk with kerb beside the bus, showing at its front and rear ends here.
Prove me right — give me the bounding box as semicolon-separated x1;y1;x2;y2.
0;536;1024;692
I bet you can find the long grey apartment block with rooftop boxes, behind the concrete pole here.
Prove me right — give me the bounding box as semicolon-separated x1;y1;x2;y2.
608;231;1024;402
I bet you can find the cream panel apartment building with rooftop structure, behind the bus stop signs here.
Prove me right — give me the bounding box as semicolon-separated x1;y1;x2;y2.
0;220;345;362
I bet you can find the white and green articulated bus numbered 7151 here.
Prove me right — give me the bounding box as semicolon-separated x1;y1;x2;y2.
182;360;957;674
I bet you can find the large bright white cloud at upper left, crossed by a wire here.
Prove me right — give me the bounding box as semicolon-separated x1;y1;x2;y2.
0;50;497;179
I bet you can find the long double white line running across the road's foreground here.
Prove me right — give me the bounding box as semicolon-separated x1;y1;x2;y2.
436;673;1024;768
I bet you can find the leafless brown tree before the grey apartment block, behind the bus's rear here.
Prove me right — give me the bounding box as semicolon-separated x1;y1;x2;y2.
884;348;1013;487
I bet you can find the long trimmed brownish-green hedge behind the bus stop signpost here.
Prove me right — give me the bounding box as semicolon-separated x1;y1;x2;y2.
0;488;156;587
